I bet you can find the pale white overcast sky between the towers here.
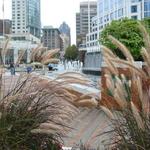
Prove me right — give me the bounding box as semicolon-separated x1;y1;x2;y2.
0;0;87;44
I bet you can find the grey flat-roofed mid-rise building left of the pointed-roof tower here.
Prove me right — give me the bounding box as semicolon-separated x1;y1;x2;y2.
42;26;62;50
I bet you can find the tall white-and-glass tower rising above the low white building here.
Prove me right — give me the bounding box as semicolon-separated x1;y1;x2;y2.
12;0;41;37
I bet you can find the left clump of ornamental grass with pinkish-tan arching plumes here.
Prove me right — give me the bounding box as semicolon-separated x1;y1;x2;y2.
0;40;96;150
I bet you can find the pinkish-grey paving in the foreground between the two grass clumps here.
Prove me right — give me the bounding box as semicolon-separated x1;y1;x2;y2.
64;108;109;150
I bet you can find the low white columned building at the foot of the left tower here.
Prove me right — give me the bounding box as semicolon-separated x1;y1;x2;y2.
0;34;40;64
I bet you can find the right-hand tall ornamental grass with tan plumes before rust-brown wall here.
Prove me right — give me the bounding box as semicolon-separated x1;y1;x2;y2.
101;24;150;150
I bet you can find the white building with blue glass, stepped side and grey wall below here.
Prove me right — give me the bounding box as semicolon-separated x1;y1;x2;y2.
80;0;150;70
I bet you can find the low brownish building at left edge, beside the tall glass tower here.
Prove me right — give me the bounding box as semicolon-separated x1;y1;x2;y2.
0;19;11;36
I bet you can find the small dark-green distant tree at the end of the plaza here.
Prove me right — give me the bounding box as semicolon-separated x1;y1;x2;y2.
64;45;78;60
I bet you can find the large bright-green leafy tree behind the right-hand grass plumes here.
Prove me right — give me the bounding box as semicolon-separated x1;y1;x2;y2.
100;19;150;60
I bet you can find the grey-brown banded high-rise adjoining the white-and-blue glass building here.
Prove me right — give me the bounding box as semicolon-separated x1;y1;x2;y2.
76;1;97;46
